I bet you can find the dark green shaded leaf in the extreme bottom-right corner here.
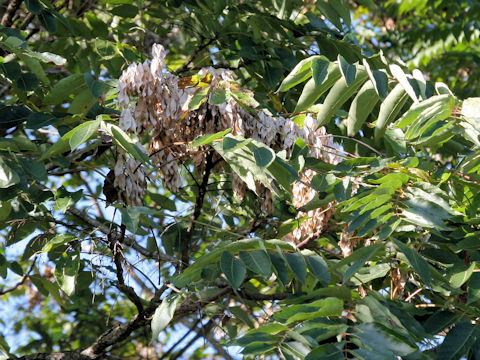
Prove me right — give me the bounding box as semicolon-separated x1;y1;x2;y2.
437;322;478;360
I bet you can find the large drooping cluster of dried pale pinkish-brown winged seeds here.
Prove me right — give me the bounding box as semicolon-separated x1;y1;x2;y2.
115;45;338;241
